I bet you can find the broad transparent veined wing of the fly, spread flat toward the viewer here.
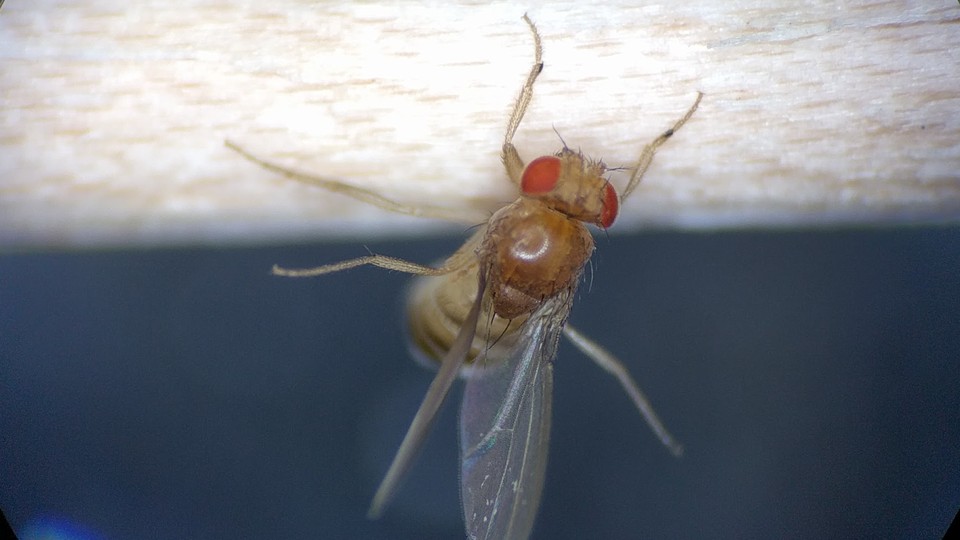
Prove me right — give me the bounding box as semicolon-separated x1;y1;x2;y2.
460;292;572;540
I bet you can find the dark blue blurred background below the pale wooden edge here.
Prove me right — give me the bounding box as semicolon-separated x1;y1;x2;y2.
0;227;960;539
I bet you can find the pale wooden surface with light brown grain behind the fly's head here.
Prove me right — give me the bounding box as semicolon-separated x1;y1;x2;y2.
0;0;960;249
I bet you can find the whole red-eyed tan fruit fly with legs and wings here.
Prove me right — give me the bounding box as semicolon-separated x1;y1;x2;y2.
226;15;703;539
